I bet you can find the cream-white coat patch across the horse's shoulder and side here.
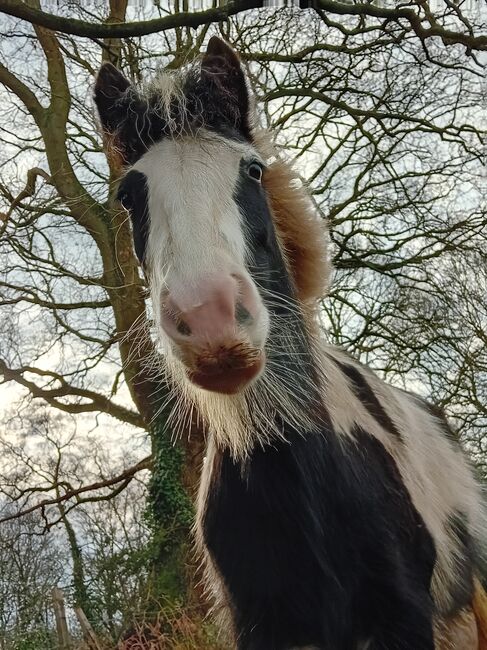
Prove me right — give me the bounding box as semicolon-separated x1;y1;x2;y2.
323;346;486;613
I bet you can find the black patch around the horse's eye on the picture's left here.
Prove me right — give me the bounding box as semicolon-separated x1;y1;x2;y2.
117;169;149;264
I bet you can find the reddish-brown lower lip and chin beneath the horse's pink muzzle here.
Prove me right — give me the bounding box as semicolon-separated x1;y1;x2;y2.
186;353;265;395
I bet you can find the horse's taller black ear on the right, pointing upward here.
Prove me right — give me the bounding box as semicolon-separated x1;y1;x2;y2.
201;36;251;140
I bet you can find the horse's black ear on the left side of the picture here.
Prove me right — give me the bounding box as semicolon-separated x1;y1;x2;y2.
94;63;131;134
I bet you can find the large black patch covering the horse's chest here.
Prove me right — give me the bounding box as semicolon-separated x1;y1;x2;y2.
203;424;435;650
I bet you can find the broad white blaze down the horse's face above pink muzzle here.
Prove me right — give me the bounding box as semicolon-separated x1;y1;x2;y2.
133;129;266;353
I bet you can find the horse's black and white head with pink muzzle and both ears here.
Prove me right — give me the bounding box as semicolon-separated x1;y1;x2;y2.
95;37;328;394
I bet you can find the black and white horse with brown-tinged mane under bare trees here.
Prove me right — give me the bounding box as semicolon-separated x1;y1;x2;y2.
94;36;487;650
